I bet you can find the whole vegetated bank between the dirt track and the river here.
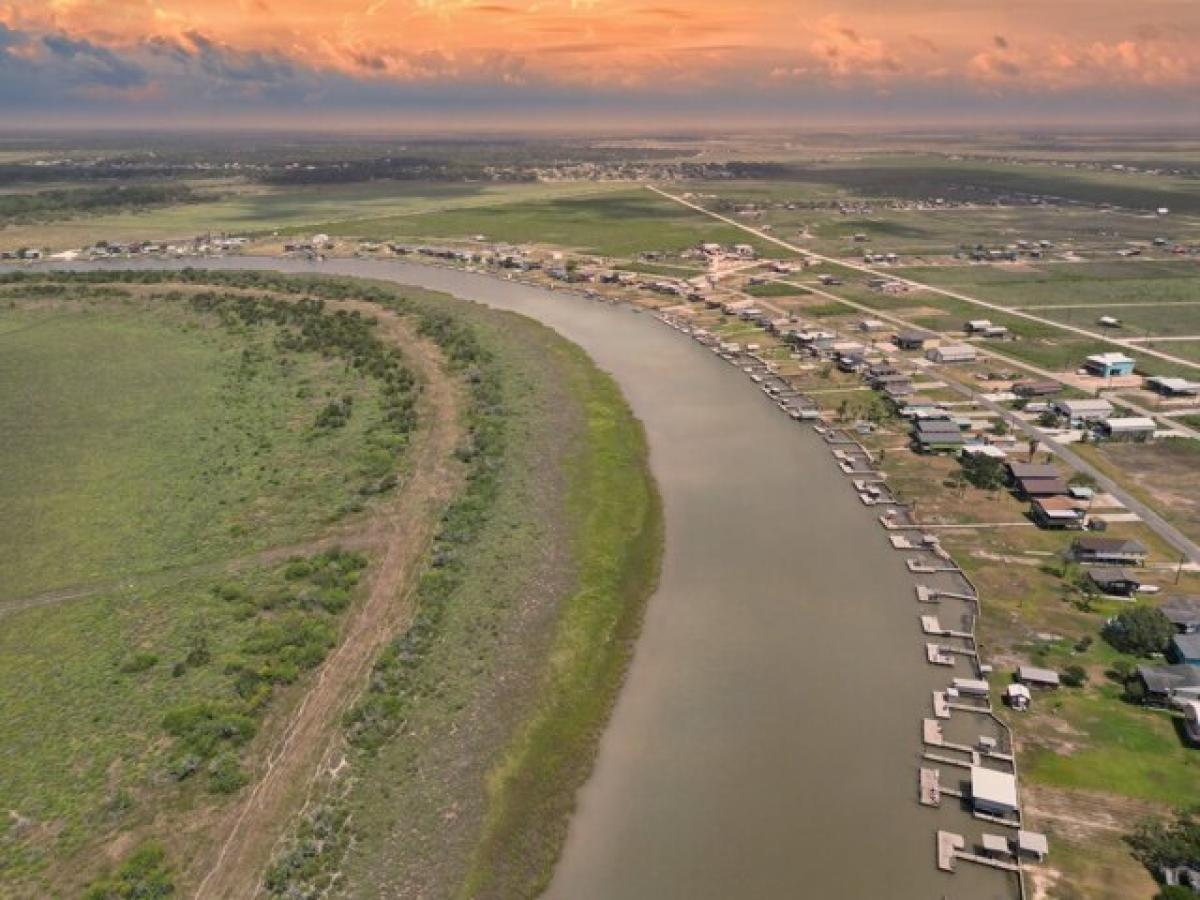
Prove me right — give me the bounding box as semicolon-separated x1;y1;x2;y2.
250;278;661;896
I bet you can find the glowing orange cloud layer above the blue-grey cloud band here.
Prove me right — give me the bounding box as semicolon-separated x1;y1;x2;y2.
7;0;1200;91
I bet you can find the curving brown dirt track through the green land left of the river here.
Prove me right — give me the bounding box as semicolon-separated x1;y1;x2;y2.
186;302;462;900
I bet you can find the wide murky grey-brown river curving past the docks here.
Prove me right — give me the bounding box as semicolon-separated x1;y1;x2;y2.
56;258;1015;900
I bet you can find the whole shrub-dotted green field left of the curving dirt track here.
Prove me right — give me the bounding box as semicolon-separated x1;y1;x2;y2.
0;281;415;896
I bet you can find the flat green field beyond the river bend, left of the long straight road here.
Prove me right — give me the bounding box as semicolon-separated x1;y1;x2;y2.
304;187;780;257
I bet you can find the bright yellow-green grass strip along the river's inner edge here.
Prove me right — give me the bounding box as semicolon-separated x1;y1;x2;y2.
461;340;662;896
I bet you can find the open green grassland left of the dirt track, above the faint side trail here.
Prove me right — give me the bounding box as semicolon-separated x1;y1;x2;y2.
0;292;386;599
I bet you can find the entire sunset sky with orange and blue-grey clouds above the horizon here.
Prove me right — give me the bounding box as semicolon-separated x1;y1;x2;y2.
0;0;1200;130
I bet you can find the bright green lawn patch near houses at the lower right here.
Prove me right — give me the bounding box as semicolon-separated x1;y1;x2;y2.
1022;689;1200;805
